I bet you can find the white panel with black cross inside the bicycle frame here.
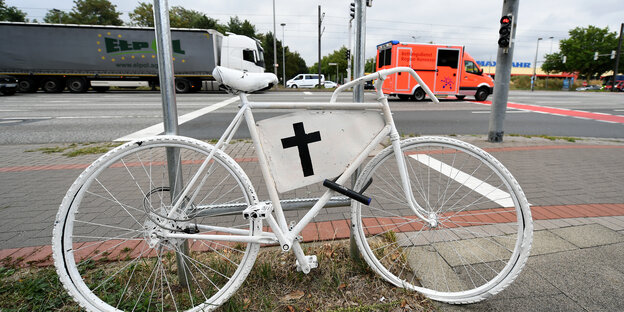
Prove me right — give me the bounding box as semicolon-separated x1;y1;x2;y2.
256;110;384;193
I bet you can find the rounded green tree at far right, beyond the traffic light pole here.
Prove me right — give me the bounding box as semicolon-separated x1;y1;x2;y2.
542;25;622;79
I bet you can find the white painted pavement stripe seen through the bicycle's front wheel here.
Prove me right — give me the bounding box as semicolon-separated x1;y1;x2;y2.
410;154;514;207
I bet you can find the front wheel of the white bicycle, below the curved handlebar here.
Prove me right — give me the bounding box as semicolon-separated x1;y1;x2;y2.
352;137;533;303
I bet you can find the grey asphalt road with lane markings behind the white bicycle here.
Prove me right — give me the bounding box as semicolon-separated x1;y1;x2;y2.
0;91;624;144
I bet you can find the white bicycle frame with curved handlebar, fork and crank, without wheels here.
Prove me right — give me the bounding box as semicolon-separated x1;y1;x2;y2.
165;67;438;273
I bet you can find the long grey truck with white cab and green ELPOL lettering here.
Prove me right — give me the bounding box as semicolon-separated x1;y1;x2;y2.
0;22;264;93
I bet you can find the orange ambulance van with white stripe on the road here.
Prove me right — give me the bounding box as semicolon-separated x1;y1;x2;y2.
377;40;494;101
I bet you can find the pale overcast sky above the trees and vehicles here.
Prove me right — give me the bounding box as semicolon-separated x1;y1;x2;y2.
5;0;624;66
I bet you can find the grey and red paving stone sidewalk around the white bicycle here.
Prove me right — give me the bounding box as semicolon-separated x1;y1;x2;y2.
0;136;624;311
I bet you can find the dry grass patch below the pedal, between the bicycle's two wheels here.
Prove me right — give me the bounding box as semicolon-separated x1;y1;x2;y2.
222;242;435;312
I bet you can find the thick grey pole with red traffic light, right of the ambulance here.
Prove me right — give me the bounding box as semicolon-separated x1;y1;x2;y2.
488;0;519;142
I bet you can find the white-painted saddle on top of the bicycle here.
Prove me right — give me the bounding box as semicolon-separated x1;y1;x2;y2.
212;66;277;94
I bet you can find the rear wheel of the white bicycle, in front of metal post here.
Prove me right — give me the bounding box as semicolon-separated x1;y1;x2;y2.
52;136;261;311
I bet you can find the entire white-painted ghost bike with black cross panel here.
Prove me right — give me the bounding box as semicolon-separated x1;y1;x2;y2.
52;68;533;311
